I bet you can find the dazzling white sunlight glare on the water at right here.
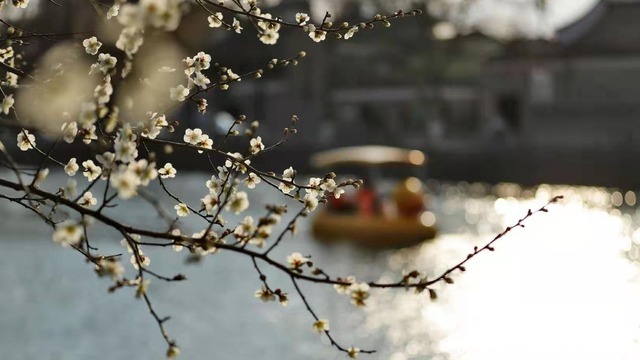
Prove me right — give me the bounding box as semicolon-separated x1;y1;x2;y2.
366;185;640;360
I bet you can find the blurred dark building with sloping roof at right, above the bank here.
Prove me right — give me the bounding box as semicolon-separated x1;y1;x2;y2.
483;0;640;150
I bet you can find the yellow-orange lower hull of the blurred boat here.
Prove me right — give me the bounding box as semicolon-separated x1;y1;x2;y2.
312;211;437;247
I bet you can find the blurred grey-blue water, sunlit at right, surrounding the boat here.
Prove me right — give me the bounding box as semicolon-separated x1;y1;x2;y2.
0;174;640;360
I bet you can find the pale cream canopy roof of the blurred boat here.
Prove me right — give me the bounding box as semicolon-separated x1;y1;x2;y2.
311;145;427;168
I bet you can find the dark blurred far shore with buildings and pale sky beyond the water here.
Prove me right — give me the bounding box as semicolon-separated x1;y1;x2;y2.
6;0;640;188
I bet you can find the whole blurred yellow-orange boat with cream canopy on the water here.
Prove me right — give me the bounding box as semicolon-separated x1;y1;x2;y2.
311;146;437;247
